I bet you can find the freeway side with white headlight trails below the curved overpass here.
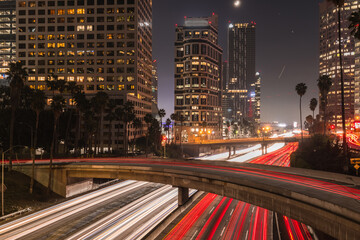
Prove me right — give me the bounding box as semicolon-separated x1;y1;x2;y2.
0;181;177;240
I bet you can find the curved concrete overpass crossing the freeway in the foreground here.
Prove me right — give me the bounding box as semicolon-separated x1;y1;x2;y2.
14;159;360;239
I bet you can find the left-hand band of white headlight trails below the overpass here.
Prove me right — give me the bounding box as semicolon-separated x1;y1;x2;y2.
0;181;165;239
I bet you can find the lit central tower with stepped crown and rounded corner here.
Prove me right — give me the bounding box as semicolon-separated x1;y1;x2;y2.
175;14;222;141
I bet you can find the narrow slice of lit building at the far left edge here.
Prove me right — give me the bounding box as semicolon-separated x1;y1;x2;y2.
0;0;16;84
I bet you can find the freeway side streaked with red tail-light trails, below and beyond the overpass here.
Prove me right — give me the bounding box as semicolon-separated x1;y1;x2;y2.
165;143;306;240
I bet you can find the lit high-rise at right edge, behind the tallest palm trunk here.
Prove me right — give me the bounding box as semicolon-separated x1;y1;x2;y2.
319;1;360;129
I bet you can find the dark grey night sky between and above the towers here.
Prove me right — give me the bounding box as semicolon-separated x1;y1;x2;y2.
153;0;319;123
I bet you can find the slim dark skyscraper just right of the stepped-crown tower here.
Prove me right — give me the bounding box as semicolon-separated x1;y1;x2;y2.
223;22;256;124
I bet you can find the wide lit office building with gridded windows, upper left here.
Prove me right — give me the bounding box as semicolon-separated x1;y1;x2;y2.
16;0;152;147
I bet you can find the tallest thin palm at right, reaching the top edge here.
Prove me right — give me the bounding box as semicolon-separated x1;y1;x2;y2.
327;0;347;162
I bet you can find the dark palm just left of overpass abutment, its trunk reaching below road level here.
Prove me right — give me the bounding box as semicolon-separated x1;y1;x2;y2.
48;94;65;193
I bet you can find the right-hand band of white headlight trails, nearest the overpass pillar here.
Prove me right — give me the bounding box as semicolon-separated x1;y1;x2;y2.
67;186;196;240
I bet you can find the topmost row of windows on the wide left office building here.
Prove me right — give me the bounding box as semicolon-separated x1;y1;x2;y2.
18;0;135;7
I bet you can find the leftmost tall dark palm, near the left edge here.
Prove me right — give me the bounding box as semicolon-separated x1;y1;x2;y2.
6;62;27;171
